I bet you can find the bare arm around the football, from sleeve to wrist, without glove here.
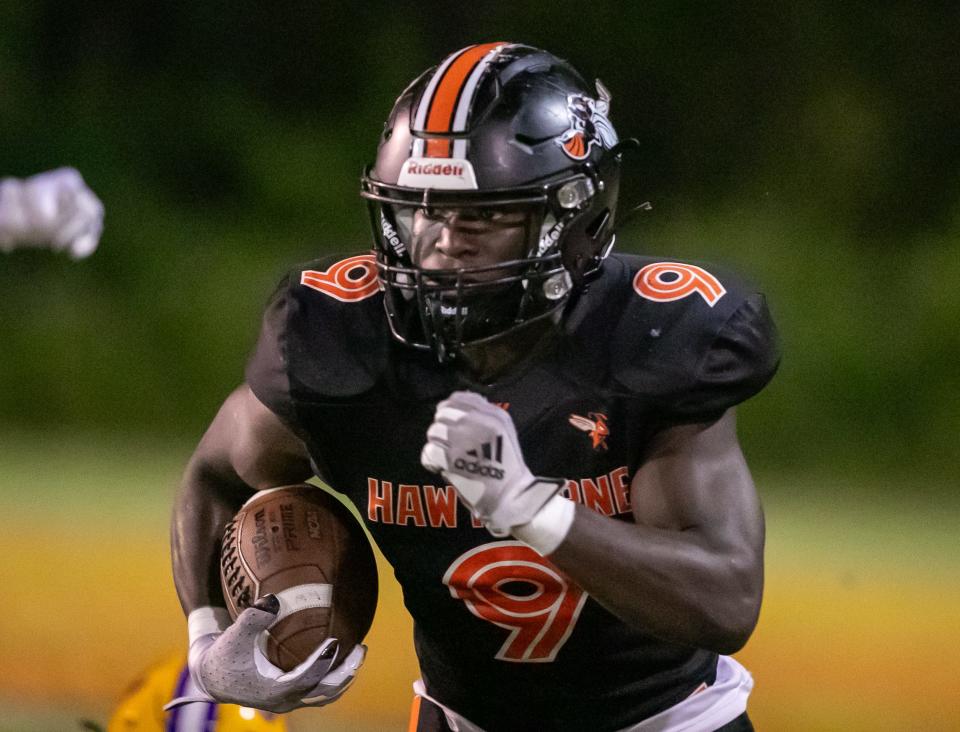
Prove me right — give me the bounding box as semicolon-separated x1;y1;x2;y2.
171;385;313;615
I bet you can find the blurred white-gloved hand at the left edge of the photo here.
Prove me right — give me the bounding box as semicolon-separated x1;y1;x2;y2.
0;168;103;259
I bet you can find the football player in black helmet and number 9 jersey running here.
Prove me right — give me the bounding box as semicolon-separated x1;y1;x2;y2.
167;43;778;732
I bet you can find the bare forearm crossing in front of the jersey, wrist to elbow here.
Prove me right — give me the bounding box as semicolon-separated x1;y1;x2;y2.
550;506;763;653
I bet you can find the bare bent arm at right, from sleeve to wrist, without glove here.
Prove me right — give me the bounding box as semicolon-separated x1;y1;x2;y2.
548;410;764;653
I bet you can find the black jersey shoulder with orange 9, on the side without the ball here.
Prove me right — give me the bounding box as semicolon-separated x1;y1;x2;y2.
611;255;779;420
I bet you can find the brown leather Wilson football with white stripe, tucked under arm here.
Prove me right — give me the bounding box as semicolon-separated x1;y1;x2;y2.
220;484;377;671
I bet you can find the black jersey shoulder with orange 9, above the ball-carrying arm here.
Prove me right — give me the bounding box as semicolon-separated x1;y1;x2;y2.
246;253;390;420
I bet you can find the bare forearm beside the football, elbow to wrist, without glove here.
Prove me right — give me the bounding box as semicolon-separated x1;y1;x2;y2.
170;459;252;614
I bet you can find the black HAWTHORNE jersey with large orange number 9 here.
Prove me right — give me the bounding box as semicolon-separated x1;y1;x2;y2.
247;255;778;730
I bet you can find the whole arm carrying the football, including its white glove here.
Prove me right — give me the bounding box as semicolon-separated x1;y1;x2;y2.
168;385;366;712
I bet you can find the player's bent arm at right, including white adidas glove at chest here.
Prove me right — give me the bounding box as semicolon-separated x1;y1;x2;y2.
421;392;763;653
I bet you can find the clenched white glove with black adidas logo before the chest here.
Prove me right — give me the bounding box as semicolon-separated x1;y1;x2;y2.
420;391;564;536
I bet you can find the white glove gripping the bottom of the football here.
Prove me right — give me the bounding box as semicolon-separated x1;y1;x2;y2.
164;596;367;713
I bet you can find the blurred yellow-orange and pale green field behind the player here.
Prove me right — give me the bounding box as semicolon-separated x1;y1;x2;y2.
0;435;960;732
